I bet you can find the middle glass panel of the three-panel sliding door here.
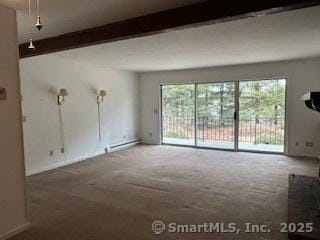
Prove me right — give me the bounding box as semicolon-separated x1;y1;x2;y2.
196;82;235;149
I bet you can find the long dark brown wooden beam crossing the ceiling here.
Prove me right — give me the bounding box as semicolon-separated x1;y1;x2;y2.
19;0;320;58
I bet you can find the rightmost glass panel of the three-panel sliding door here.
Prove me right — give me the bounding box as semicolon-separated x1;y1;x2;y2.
239;79;286;153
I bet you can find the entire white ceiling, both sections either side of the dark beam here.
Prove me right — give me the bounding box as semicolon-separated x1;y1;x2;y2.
0;0;320;72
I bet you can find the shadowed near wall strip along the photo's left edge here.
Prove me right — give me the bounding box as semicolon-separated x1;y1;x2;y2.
0;6;29;240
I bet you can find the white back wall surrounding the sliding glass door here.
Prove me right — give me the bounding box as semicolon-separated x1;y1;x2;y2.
140;59;320;156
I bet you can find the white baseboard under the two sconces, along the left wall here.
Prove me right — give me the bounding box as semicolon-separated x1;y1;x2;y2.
26;151;106;177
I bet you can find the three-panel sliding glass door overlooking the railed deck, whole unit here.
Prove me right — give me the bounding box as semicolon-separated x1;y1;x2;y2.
161;79;286;153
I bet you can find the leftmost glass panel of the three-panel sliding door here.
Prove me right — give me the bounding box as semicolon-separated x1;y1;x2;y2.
161;84;195;146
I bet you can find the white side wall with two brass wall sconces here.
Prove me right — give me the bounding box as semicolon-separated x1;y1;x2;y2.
20;54;139;174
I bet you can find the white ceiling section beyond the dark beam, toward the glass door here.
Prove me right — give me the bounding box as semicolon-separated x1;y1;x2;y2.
53;7;320;72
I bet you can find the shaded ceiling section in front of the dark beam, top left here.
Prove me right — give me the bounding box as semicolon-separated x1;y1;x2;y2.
0;0;203;43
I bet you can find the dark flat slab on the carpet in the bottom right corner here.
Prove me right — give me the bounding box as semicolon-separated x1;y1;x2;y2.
288;174;320;240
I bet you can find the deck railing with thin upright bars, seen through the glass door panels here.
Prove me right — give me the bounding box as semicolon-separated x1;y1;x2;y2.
162;116;284;145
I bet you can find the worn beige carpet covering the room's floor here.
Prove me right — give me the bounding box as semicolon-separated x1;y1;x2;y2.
12;145;317;240
